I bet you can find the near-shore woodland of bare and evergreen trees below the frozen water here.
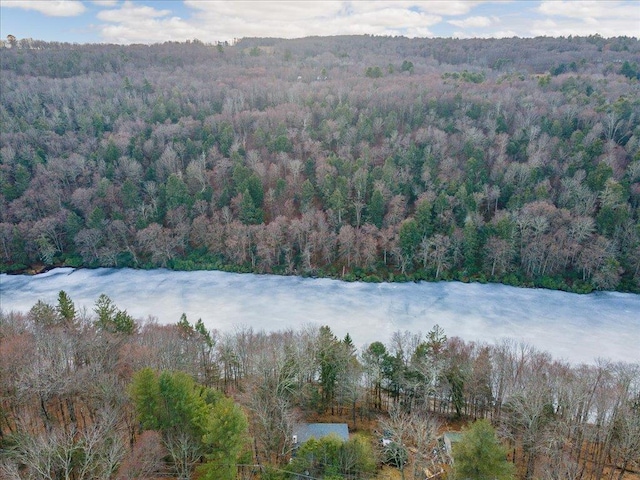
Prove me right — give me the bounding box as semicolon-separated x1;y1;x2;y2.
0;291;640;480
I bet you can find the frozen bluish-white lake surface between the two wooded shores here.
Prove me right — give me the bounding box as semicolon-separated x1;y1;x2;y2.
0;268;640;363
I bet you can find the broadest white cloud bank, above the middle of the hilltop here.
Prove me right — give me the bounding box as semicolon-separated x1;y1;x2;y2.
97;0;450;43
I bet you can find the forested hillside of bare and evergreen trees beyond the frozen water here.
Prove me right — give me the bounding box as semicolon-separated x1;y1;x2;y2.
0;35;640;292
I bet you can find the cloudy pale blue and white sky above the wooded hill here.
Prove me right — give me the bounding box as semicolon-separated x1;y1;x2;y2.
0;0;640;44
